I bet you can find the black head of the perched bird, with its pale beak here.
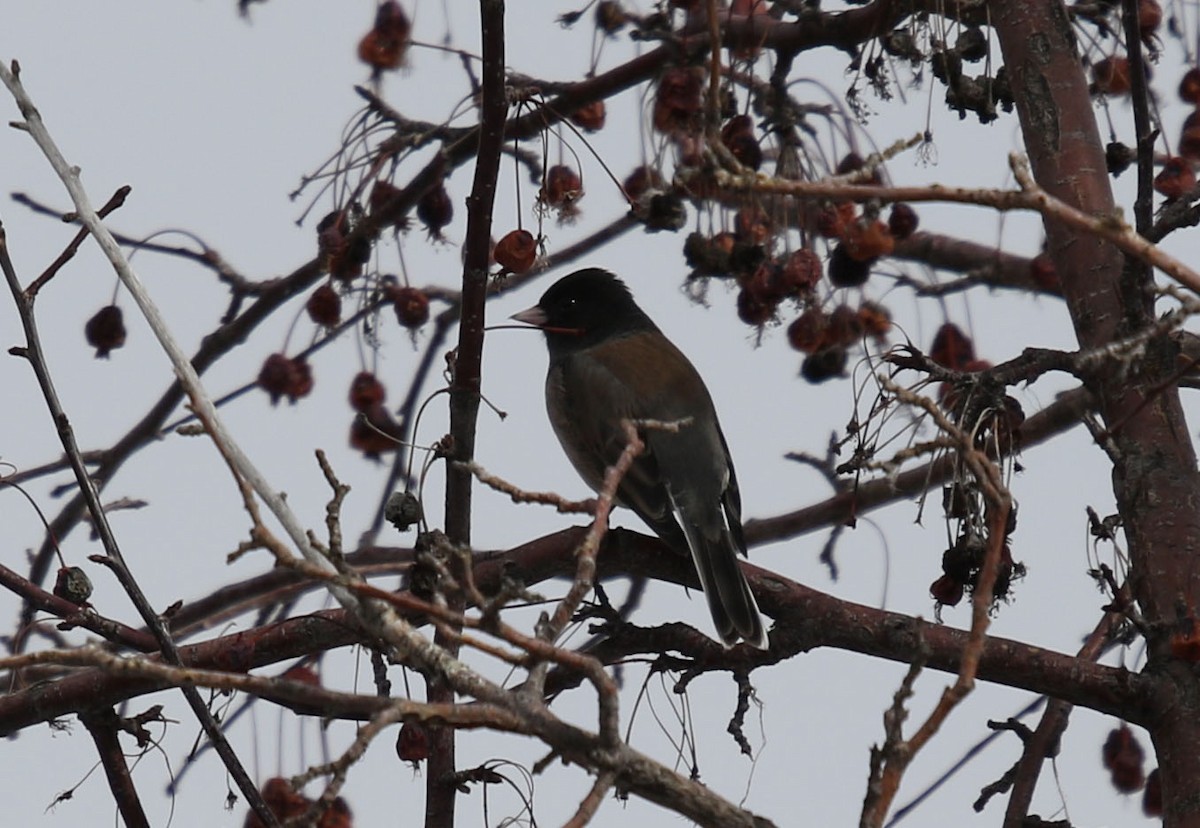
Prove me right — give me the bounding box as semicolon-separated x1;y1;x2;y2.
512;268;658;354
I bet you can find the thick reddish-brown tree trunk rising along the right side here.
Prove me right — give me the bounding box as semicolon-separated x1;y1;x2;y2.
989;0;1200;827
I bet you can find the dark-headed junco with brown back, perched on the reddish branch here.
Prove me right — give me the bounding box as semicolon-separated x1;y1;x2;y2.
512;268;767;648
